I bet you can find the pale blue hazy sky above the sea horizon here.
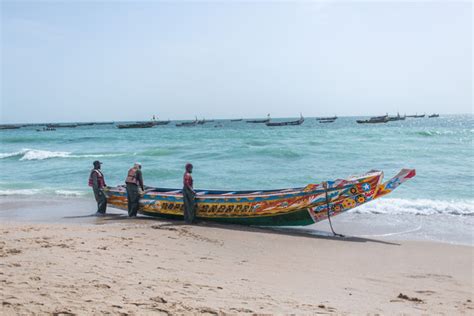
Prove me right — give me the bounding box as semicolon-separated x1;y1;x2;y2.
1;1;473;123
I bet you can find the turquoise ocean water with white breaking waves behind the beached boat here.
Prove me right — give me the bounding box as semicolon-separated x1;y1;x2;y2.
0;115;474;244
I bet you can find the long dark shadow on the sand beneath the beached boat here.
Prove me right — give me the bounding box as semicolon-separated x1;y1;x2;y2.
90;214;400;246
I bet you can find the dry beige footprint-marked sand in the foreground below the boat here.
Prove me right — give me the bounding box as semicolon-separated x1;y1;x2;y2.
0;216;474;315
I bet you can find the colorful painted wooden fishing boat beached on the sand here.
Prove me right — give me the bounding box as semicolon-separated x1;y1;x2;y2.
105;169;416;226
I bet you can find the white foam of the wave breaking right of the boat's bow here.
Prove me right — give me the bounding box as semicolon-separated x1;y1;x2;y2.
352;198;474;216
